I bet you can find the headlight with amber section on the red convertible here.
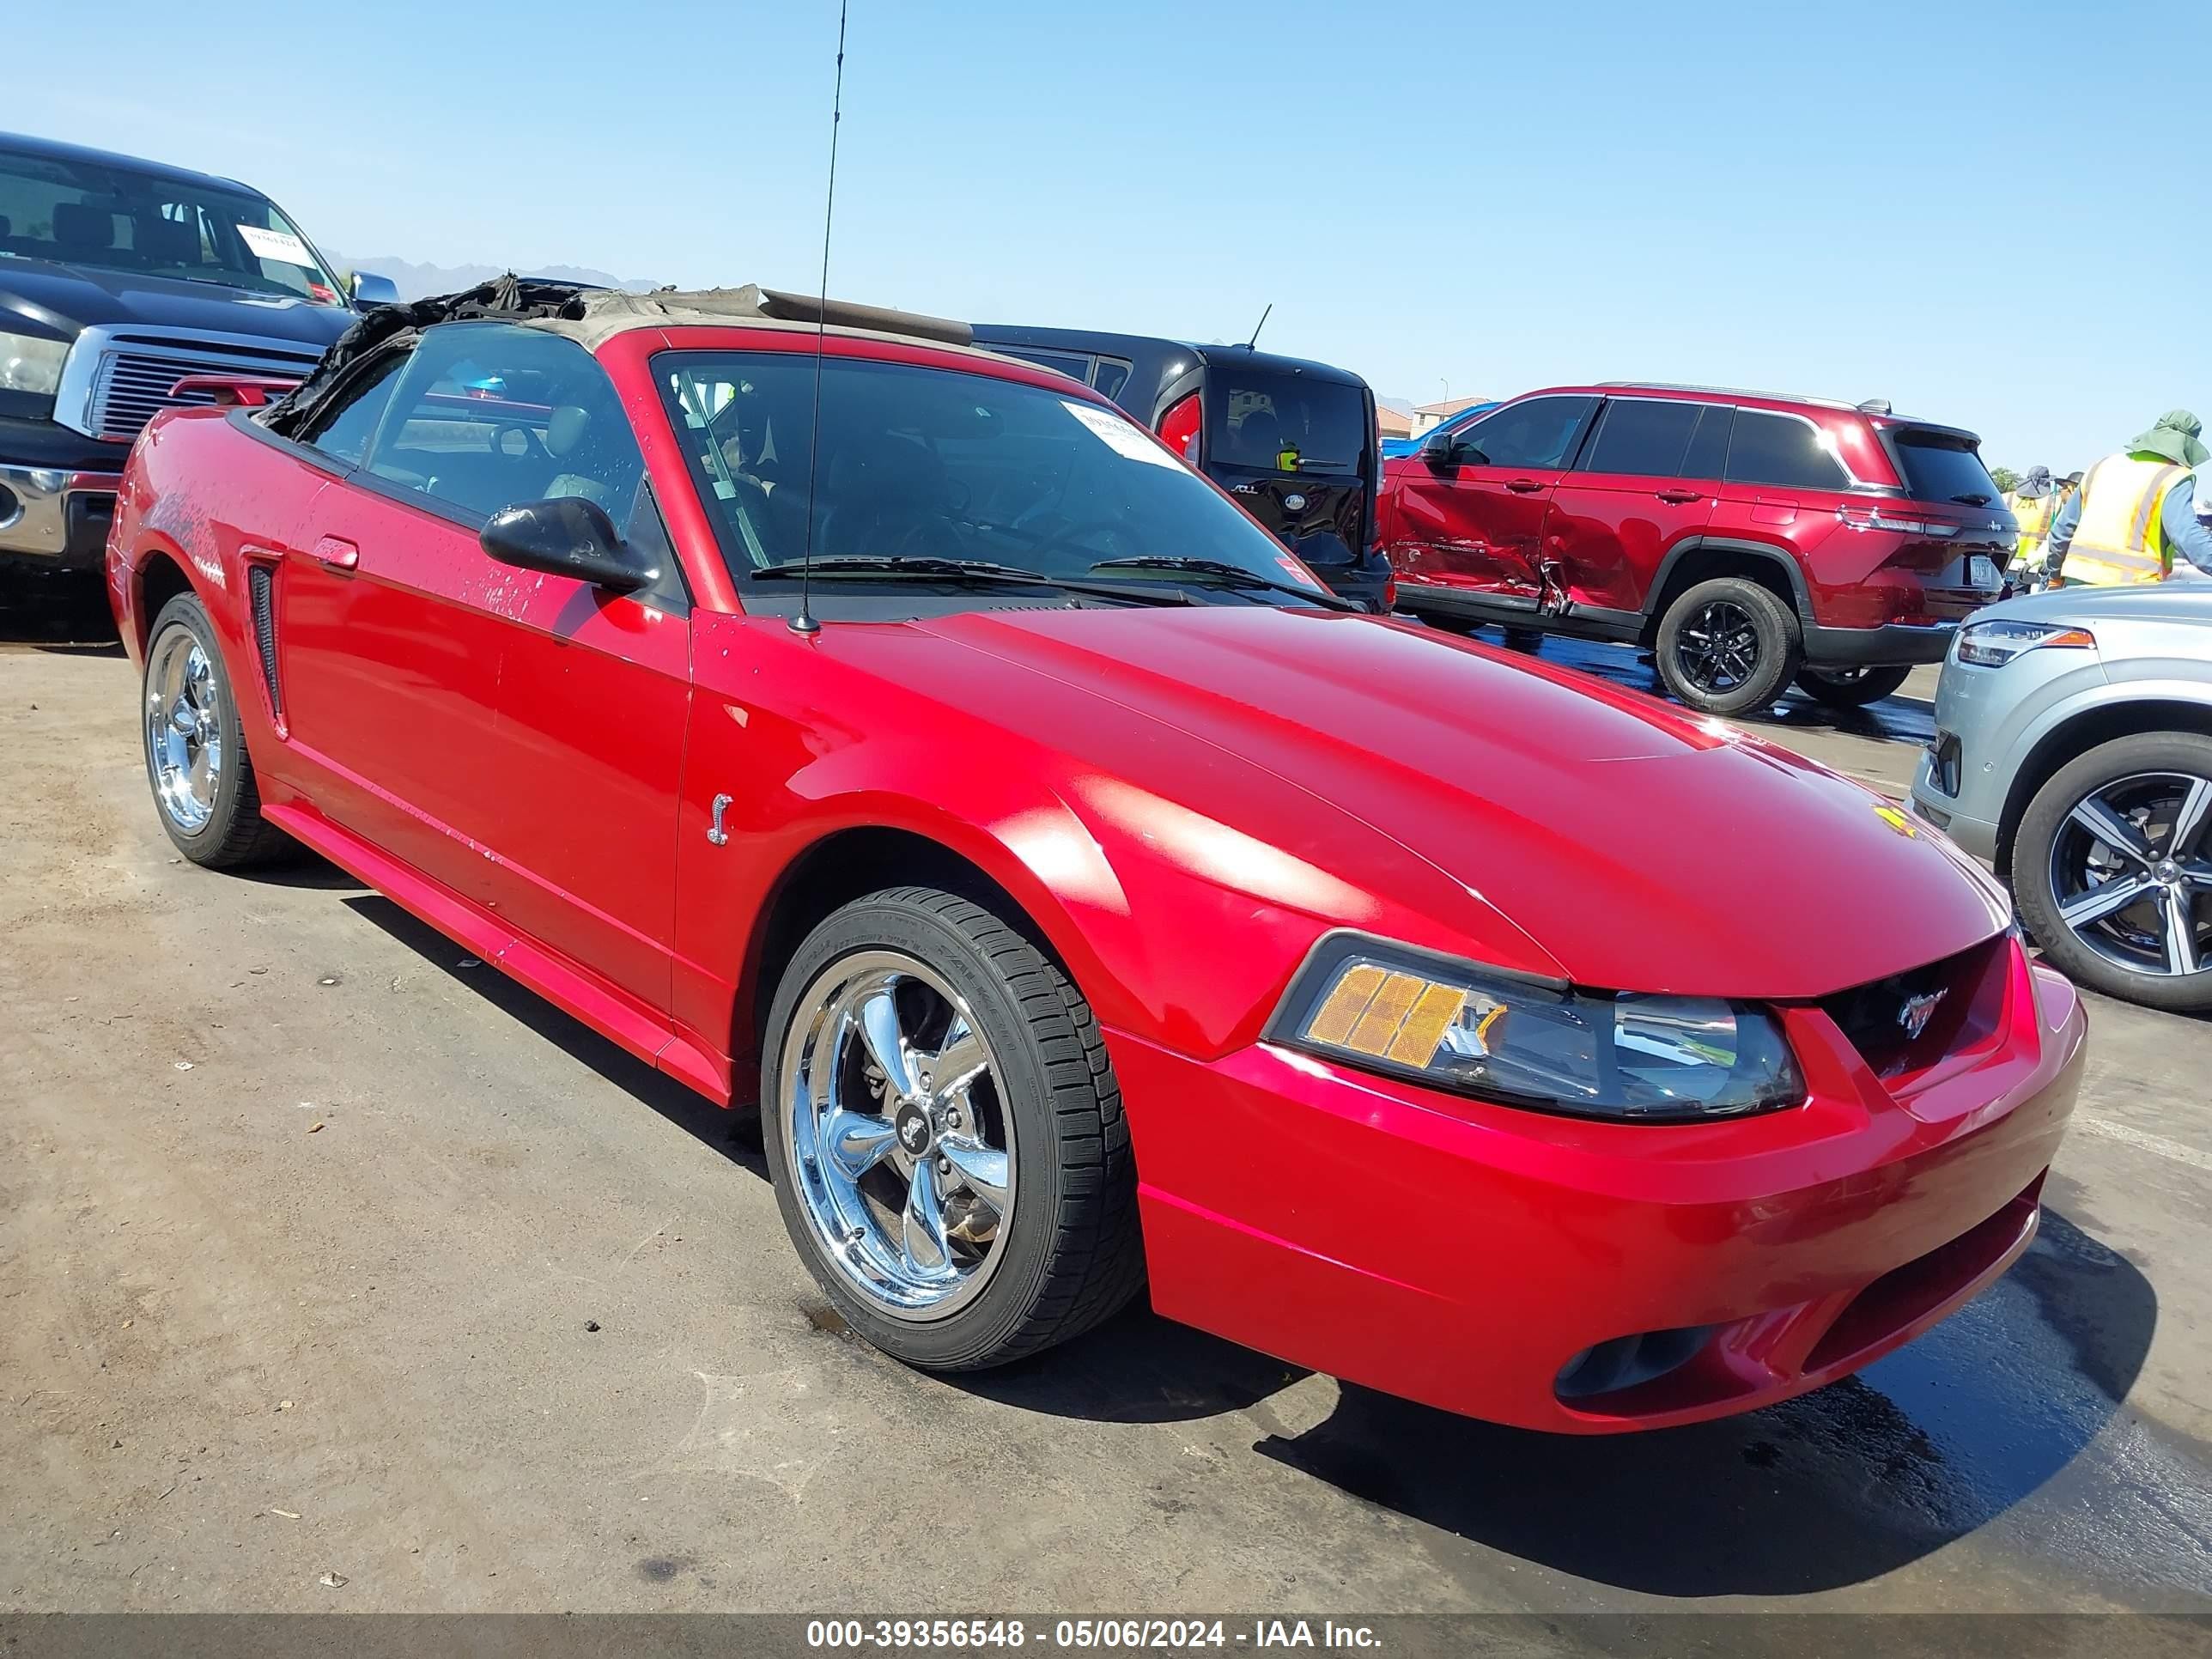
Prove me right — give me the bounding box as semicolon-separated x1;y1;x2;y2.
1270;933;1805;1121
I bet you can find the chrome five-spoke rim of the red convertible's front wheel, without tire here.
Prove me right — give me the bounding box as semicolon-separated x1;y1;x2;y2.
779;949;1015;1321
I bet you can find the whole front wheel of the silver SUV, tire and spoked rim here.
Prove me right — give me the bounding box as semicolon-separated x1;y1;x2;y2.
2013;732;2212;1013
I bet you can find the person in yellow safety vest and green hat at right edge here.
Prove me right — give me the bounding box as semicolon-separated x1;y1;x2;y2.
2044;410;2212;588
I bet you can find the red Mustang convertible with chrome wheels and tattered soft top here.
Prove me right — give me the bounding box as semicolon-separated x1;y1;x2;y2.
108;281;2084;1431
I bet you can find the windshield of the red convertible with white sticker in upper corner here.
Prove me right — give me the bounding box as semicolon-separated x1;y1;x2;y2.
654;352;1310;601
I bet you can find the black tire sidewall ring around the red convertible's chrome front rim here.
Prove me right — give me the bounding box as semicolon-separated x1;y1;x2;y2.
761;894;1084;1371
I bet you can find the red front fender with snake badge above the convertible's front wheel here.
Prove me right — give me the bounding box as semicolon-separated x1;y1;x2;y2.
675;613;1380;1084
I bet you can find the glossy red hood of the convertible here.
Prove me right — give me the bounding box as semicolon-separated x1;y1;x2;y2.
905;606;2011;1000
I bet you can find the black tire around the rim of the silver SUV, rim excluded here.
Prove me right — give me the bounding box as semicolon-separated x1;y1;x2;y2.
2011;732;2212;1013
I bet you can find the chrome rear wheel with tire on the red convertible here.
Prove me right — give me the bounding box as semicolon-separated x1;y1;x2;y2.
139;592;292;869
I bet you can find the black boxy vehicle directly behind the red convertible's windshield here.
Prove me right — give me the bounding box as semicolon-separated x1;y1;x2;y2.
973;323;1391;613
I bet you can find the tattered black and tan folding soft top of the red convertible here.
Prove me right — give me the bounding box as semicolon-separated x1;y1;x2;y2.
254;274;973;435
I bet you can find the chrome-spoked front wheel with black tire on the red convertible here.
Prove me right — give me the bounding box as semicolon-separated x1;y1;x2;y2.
761;887;1144;1371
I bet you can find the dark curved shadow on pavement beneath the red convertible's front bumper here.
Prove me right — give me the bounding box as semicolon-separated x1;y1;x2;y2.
1256;1210;2159;1597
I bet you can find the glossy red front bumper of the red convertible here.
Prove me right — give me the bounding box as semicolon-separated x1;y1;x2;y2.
1109;945;2086;1433
